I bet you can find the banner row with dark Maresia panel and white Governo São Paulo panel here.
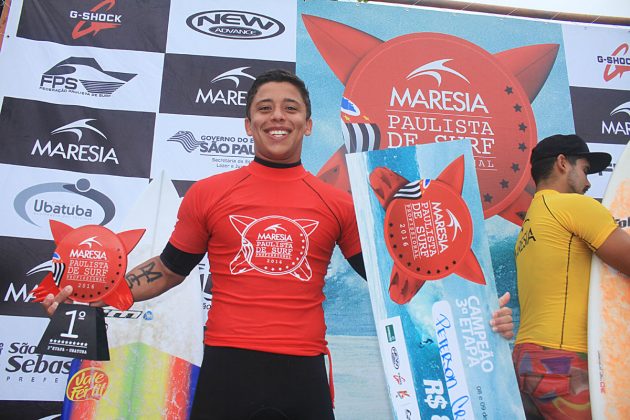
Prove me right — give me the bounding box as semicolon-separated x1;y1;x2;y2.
0;97;254;180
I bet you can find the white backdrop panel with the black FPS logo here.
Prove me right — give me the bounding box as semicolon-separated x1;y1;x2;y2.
0;38;164;112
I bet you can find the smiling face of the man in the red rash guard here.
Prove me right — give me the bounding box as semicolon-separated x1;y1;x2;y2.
245;82;313;163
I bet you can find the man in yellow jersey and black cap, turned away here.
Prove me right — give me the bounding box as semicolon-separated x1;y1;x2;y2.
512;134;630;420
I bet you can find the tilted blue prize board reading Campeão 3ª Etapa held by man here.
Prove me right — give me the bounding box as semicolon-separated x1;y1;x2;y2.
347;140;524;420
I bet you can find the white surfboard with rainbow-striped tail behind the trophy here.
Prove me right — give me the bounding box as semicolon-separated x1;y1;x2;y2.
63;171;203;420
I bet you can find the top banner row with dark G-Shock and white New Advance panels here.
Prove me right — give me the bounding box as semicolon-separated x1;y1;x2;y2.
17;0;296;54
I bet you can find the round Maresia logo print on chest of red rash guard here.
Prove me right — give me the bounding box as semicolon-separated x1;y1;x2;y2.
230;215;319;281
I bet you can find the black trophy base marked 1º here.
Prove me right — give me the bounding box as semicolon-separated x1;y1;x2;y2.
35;303;109;360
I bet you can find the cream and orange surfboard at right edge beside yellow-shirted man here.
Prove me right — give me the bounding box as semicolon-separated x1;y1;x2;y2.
588;145;630;420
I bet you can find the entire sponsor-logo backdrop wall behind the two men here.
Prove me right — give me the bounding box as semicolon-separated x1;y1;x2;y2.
0;0;630;419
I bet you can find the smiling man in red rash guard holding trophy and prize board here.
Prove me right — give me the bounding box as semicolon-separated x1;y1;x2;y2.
44;70;513;420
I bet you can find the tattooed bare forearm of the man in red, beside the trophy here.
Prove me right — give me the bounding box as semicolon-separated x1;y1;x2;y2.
125;256;185;302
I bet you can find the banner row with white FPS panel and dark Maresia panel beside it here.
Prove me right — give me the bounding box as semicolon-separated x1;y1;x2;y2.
0;48;295;118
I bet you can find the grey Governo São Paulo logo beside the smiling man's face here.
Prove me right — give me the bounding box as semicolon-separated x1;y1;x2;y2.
166;130;254;158
